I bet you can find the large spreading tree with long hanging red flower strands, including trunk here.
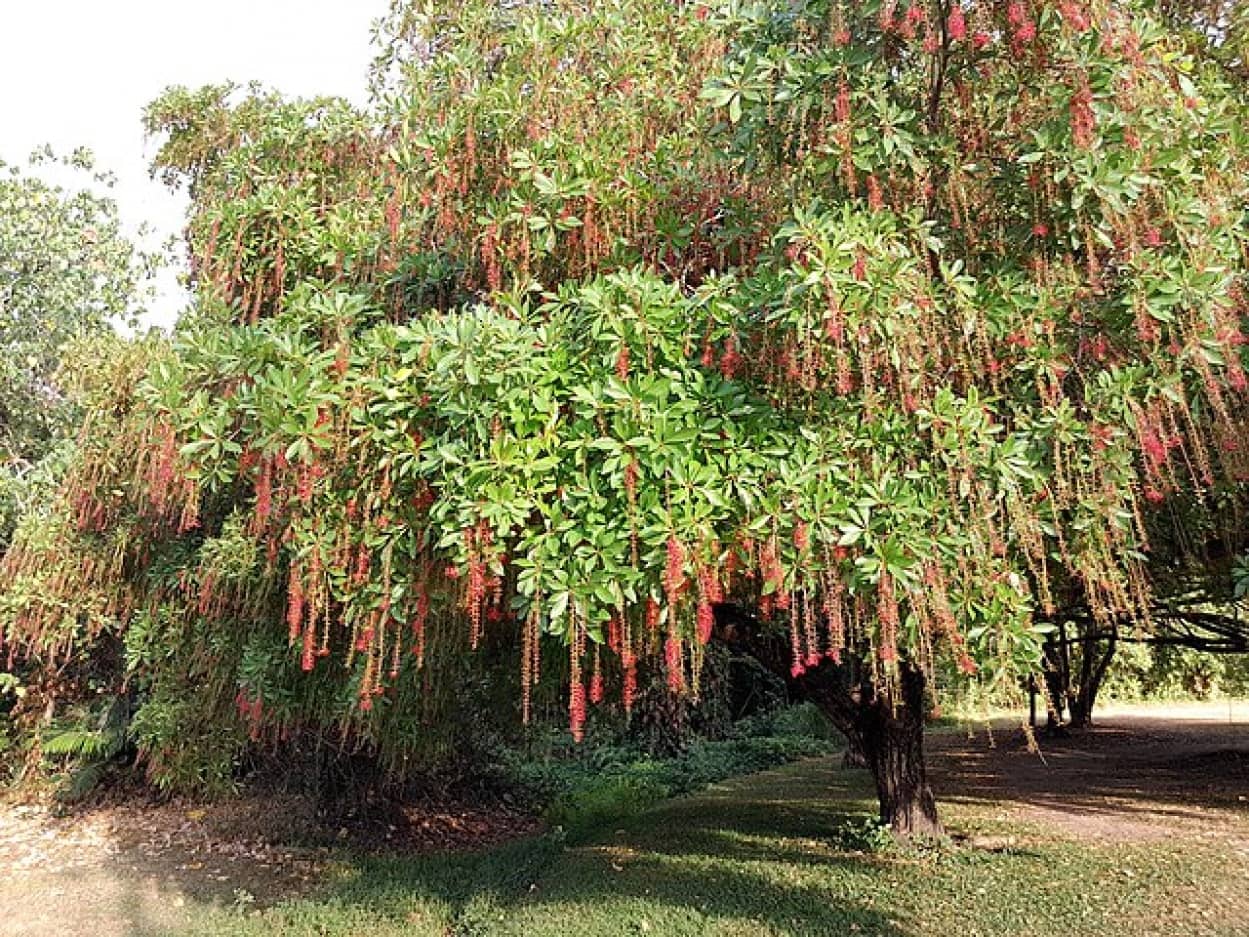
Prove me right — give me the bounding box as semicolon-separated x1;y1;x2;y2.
4;0;1249;833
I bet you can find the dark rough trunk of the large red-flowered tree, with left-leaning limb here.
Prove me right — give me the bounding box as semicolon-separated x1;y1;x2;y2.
717;606;942;838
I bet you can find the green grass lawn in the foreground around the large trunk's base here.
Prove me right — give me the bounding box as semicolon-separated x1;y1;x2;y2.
151;758;1249;937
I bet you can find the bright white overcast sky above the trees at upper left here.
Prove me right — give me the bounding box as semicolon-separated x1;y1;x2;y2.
0;0;388;324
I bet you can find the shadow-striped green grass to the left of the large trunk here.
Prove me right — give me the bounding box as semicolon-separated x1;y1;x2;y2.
251;762;908;937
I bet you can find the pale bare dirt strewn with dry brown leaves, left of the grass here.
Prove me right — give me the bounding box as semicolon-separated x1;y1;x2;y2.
0;797;537;937
